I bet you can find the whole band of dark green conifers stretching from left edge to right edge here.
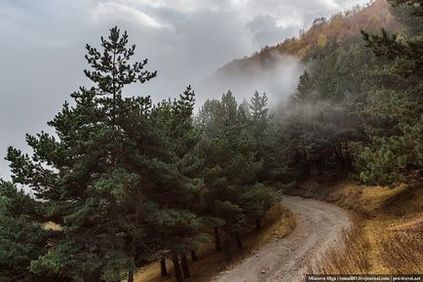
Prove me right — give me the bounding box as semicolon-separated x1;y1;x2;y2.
0;1;423;281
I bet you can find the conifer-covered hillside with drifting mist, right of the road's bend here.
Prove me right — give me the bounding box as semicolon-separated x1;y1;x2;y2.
276;2;423;185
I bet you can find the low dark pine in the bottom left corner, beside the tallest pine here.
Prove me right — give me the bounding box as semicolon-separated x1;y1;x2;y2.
0;180;57;281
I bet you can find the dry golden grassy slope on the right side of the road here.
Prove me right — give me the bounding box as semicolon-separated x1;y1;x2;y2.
289;179;423;274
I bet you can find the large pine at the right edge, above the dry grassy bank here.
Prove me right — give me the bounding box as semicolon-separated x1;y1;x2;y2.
357;0;423;184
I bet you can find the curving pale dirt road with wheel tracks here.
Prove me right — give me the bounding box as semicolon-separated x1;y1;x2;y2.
214;196;351;282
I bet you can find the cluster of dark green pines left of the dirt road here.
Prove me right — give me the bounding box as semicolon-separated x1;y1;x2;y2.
0;27;274;281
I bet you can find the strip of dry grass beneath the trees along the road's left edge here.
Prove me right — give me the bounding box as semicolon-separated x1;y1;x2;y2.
135;204;295;282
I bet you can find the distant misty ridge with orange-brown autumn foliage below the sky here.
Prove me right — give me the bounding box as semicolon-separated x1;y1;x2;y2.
215;0;400;81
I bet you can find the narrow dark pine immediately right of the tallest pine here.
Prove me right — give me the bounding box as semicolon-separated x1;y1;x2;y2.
147;86;207;279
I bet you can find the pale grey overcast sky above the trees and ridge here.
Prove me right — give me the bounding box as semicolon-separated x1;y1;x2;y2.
0;0;367;178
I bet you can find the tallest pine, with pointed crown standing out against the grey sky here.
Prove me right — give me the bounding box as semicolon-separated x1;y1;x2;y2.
7;27;177;281
